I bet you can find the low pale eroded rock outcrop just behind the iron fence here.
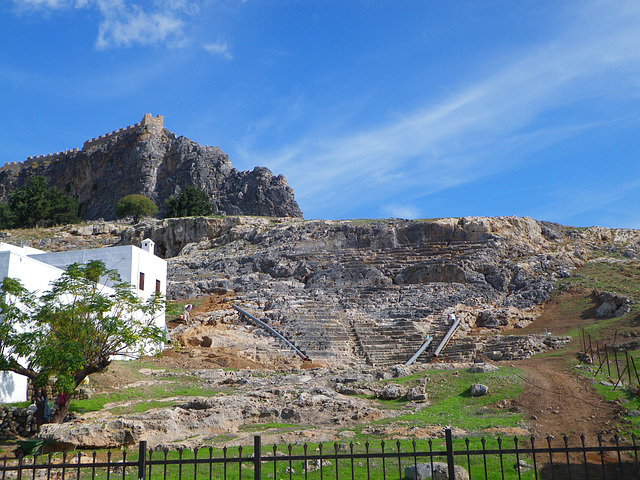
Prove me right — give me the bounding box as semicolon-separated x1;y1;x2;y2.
40;376;393;448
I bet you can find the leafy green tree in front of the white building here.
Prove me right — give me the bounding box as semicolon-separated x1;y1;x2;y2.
0;260;164;422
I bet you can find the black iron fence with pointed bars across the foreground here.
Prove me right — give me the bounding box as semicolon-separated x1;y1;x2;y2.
0;429;640;480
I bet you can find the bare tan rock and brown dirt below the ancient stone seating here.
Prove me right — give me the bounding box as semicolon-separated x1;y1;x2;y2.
33;297;623;449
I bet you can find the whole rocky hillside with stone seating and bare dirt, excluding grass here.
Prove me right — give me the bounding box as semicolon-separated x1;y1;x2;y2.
2;217;640;447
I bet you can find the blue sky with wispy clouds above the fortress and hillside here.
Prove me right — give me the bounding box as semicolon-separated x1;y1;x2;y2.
0;0;640;228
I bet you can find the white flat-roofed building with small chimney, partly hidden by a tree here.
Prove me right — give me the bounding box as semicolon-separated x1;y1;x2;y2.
0;239;167;403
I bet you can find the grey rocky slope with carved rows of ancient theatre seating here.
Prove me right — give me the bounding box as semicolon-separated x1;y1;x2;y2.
12;217;640;365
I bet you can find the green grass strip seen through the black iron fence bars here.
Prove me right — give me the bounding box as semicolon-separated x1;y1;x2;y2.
48;435;546;480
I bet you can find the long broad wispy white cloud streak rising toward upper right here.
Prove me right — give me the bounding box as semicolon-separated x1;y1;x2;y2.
254;2;640;218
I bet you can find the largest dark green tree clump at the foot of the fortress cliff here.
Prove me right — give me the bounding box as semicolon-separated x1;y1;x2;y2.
8;177;79;227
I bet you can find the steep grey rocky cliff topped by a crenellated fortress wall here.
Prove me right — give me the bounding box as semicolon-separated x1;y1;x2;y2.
0;114;302;219
